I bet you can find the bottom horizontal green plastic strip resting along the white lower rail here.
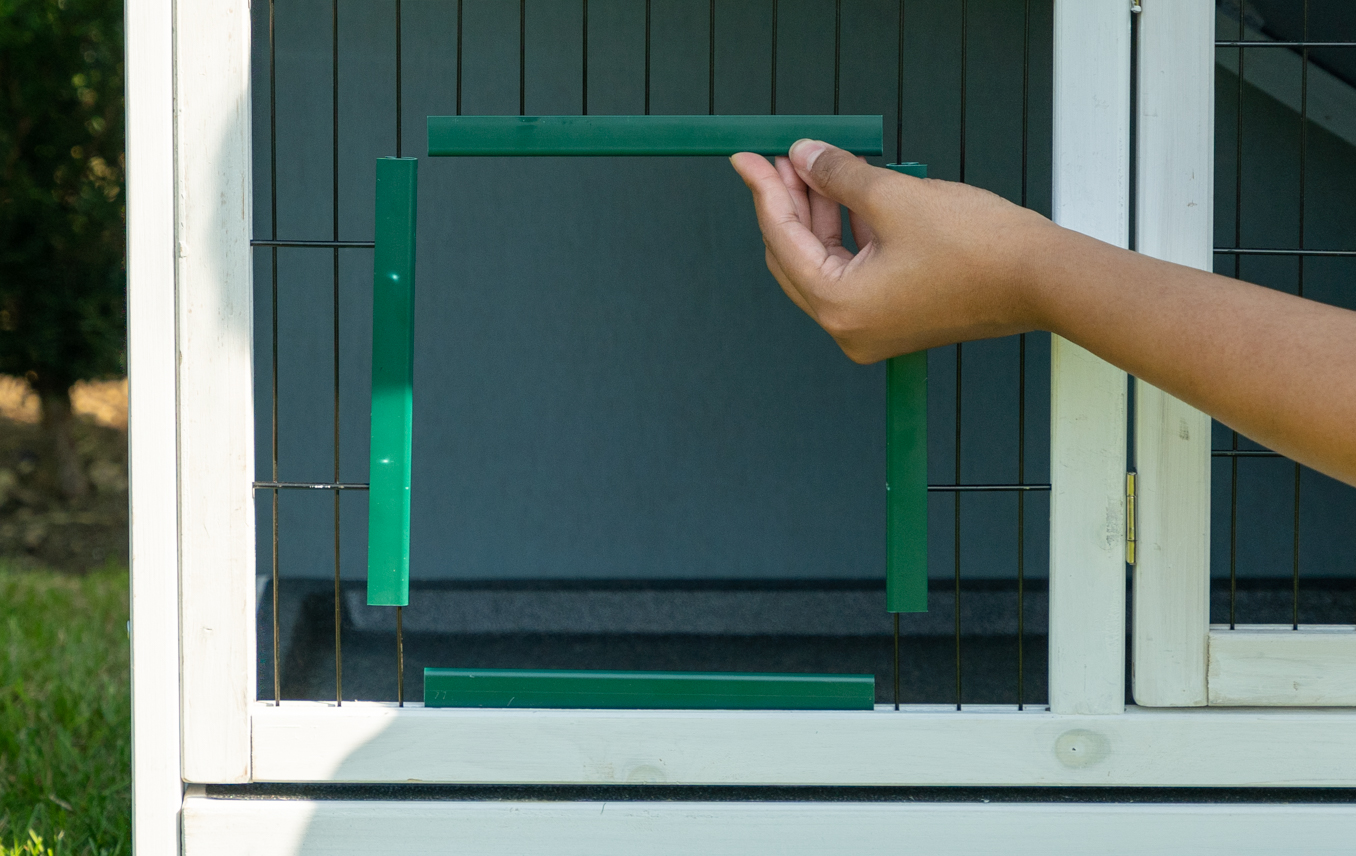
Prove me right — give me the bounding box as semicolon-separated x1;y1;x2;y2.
424;669;876;711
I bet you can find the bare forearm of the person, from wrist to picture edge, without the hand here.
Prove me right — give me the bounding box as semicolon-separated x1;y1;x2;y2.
1022;223;1356;484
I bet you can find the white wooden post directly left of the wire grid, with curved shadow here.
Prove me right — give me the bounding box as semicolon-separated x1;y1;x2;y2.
175;0;255;783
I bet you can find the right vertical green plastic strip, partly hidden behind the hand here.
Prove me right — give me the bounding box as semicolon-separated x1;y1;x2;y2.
885;163;928;612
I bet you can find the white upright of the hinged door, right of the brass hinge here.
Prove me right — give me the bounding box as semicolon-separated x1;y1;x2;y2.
1132;0;1215;707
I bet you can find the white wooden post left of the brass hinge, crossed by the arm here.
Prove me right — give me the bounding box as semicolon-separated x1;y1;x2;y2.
1050;0;1131;714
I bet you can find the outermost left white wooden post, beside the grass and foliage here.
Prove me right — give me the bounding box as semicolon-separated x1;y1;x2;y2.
125;0;183;856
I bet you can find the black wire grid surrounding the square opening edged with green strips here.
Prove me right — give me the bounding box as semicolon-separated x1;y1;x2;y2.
250;0;1046;711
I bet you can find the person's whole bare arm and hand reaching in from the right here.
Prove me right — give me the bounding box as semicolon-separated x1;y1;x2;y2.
731;141;1356;484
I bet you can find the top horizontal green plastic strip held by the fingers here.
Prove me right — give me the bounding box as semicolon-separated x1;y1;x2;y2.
428;115;883;157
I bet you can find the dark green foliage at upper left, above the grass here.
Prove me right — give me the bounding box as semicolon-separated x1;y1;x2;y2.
0;0;126;395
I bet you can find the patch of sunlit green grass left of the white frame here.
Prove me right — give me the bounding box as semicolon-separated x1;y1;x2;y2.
0;563;132;856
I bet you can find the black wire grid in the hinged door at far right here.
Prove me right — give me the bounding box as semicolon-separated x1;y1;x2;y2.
1211;0;1356;631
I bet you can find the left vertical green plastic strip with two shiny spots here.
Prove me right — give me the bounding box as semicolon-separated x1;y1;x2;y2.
367;157;419;606
